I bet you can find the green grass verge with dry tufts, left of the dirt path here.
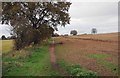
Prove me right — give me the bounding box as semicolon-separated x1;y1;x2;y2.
2;39;58;76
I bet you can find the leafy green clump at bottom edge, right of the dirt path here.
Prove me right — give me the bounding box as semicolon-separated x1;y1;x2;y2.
58;60;97;77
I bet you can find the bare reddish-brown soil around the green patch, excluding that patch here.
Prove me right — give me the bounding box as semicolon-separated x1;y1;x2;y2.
55;34;118;76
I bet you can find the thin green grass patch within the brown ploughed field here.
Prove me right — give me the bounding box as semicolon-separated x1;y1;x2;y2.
88;54;118;73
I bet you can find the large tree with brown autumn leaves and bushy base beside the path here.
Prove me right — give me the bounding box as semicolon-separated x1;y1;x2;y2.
2;2;71;49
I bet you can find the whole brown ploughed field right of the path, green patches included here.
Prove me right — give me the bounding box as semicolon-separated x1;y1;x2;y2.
54;33;119;76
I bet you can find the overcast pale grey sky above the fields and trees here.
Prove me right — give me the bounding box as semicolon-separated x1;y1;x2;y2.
0;0;118;36
